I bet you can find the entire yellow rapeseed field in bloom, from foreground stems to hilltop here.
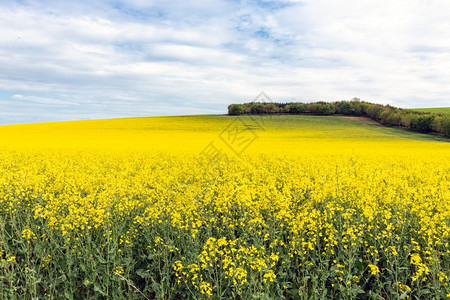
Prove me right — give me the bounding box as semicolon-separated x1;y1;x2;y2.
0;116;450;299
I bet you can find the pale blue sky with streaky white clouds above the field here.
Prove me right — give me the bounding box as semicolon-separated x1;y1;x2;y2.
0;0;450;124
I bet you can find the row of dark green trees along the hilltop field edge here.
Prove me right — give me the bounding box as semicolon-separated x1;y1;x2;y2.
228;98;450;137
